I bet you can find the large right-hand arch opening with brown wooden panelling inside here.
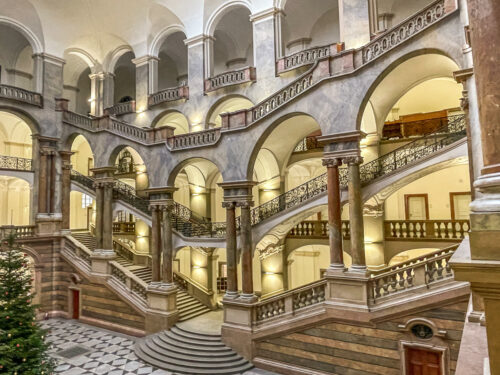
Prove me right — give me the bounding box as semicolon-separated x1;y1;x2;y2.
360;54;462;162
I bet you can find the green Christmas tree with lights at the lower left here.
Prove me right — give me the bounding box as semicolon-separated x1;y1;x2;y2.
0;234;55;375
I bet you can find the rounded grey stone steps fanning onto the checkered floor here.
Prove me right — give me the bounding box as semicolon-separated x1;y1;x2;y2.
135;325;253;375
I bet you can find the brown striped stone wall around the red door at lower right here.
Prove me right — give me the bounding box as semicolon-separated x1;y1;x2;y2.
255;300;468;375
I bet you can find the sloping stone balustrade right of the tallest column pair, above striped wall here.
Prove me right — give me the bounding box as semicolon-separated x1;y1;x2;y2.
369;244;458;303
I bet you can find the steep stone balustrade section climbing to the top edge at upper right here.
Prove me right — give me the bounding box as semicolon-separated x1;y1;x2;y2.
362;0;447;64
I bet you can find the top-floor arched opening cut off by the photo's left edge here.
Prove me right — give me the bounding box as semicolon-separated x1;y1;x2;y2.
0;24;36;91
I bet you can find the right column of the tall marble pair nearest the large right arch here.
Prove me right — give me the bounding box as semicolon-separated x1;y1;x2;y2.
343;156;366;273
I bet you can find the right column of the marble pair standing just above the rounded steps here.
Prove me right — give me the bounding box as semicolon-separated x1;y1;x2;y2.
237;201;257;302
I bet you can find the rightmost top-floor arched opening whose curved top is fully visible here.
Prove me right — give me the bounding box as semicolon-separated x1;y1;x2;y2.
212;6;254;75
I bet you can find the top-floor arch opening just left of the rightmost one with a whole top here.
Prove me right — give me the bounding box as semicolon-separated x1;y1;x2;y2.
158;31;188;91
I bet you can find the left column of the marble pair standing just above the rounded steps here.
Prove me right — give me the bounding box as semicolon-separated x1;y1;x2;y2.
222;202;238;299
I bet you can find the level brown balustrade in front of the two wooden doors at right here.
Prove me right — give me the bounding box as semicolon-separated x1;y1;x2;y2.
384;220;470;241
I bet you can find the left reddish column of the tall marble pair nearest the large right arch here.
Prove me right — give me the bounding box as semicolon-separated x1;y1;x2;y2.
323;158;345;272
